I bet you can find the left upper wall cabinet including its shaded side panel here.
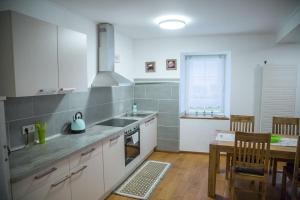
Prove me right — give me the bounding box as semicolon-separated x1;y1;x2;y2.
0;11;58;97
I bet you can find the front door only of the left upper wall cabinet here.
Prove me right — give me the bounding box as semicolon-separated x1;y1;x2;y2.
11;12;58;96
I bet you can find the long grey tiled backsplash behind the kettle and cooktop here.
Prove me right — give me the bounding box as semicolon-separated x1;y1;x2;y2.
5;86;133;147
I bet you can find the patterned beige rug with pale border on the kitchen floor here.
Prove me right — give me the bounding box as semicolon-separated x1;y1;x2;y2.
115;160;171;199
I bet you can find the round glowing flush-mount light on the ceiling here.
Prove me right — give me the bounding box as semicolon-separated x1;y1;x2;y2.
154;15;190;30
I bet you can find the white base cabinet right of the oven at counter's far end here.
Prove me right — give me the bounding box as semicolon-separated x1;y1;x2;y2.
140;117;157;158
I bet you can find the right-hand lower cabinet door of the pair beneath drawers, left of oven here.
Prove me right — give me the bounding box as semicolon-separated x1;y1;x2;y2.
70;152;104;200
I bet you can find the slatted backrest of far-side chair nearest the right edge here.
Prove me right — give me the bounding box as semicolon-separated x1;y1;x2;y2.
272;117;299;135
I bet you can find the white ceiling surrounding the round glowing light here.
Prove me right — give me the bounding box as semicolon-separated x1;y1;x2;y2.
50;0;300;38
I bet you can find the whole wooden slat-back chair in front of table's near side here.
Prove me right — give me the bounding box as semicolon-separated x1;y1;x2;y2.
230;132;271;199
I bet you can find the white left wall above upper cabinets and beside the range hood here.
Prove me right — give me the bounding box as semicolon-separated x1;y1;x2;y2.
0;0;132;85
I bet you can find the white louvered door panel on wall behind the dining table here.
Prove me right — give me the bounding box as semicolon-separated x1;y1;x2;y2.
260;65;297;132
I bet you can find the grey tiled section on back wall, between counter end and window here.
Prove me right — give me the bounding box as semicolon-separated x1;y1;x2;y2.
134;83;179;151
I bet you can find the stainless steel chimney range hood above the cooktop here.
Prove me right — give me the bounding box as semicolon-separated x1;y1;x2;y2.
92;23;133;87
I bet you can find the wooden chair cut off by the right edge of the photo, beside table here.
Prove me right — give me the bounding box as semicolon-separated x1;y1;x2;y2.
281;136;300;200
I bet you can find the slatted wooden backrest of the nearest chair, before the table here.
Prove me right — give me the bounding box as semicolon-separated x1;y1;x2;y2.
233;132;271;172
